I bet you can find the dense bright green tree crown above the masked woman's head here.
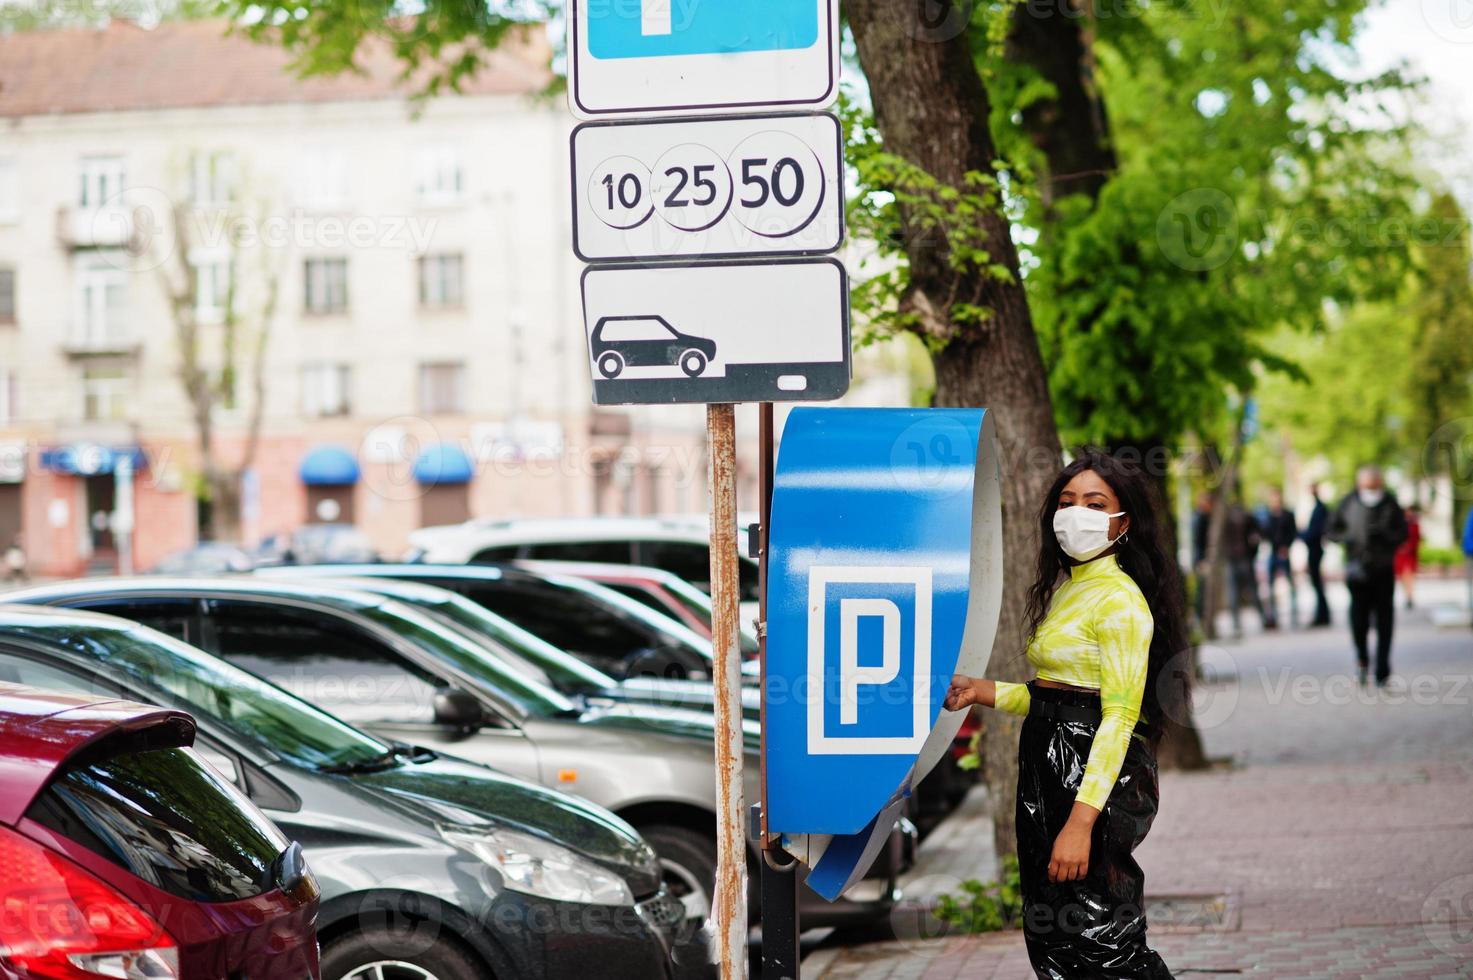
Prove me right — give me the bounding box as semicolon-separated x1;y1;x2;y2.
981;0;1416;444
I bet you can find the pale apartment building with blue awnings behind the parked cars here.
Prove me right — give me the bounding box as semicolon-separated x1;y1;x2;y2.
0;22;724;575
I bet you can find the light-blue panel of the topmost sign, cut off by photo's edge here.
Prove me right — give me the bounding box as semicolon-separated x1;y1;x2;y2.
588;0;819;57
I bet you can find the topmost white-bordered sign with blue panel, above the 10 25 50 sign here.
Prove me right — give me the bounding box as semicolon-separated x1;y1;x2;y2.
567;0;838;119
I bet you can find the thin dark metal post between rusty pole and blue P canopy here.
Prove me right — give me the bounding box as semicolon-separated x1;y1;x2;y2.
757;401;803;980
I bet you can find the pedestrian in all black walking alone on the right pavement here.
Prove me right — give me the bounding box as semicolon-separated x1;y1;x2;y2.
1327;466;1407;687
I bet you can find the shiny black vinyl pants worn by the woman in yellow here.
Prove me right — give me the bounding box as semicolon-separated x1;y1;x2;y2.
1018;684;1171;980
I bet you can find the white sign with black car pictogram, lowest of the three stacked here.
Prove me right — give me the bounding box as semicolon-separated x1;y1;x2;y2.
583;258;850;405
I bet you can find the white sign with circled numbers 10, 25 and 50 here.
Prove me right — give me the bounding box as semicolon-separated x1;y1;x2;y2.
572;112;844;262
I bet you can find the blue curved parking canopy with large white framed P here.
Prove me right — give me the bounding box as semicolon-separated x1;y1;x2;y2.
763;408;1003;899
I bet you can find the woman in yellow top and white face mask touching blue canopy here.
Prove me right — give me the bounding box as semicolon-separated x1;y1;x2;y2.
946;449;1187;980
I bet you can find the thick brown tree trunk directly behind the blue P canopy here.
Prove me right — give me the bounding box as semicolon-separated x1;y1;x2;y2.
846;0;1059;853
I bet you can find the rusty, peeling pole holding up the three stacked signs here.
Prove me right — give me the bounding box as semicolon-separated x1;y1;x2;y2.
706;405;747;980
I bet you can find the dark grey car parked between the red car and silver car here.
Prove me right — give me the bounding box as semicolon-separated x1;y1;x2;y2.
0;606;681;980
